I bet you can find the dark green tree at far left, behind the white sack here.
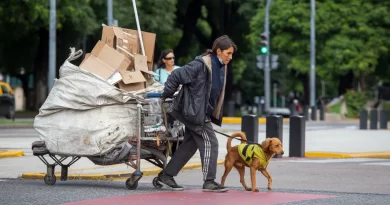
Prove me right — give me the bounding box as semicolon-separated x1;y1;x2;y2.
0;0;98;107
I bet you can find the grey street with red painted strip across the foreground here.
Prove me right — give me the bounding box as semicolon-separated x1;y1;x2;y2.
0;158;390;205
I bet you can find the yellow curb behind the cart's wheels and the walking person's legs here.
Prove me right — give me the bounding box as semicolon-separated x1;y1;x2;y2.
20;160;225;180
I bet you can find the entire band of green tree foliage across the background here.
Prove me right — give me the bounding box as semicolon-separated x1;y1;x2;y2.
0;0;390;109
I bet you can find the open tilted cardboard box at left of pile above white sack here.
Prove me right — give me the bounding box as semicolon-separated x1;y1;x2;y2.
79;41;130;84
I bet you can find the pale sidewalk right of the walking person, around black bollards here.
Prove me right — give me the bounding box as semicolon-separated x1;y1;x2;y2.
213;129;390;158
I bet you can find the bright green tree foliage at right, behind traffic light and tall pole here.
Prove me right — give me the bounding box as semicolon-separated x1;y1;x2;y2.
248;0;390;99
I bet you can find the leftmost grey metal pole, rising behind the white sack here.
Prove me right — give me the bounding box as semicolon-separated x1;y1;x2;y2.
47;0;57;92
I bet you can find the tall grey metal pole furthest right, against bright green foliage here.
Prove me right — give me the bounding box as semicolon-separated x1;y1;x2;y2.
310;0;316;107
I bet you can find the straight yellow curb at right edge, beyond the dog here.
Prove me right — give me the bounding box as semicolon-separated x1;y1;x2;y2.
305;152;390;159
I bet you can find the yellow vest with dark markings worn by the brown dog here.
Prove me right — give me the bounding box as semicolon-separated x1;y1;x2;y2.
238;144;268;169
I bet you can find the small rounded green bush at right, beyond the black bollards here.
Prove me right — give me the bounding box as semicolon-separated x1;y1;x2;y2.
344;90;368;118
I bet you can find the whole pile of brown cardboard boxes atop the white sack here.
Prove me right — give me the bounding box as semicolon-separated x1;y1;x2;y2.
79;25;157;91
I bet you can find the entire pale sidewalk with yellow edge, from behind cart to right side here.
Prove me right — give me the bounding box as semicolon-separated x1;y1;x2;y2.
0;129;390;180
